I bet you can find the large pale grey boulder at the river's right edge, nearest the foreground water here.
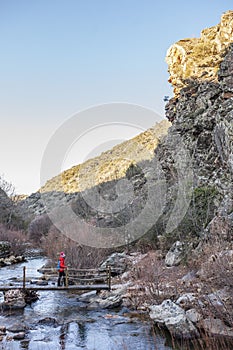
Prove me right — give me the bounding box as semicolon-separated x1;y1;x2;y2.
149;299;199;339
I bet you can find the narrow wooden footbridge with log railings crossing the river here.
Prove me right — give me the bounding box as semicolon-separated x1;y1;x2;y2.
0;266;111;292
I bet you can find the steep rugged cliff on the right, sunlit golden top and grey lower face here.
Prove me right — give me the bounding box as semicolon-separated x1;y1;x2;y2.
160;11;233;246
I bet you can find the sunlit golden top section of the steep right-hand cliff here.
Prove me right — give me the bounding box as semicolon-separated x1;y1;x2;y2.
166;11;233;96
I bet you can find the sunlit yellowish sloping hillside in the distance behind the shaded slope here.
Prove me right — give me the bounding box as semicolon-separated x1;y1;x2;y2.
39;120;171;193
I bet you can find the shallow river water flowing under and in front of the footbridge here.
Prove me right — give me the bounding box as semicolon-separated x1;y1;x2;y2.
0;258;172;350
